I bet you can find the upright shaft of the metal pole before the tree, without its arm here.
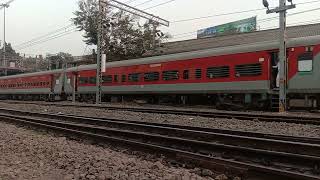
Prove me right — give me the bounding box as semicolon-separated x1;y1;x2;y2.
96;0;104;104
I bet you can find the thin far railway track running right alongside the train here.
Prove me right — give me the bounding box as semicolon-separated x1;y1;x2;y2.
2;101;320;125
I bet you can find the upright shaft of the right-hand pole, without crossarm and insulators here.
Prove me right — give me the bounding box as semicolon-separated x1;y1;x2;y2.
279;0;287;112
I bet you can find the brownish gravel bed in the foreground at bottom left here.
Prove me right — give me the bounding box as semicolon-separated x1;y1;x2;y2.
0;122;221;180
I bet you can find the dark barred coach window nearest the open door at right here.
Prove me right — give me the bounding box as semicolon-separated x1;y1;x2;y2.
235;63;262;77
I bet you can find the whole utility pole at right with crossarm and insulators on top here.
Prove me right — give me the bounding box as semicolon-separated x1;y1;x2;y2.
263;0;296;113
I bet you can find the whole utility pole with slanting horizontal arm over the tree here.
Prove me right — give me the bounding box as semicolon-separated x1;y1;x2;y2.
96;0;170;104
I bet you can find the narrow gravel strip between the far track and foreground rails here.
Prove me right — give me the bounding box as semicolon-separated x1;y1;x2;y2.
0;103;320;137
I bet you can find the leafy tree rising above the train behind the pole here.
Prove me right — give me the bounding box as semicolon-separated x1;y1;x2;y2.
72;0;168;60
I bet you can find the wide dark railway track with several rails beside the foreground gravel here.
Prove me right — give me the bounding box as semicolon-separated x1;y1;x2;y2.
0;108;320;179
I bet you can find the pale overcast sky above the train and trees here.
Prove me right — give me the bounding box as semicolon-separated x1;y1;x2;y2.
0;0;320;55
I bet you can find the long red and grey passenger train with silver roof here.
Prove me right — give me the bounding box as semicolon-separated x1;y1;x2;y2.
0;36;320;109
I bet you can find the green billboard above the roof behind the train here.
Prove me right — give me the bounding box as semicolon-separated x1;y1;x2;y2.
197;16;257;38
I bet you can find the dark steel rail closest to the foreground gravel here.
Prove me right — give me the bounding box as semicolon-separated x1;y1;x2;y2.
2;114;320;180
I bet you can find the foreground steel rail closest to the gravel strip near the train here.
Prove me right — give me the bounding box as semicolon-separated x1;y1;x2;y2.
0;108;320;156
